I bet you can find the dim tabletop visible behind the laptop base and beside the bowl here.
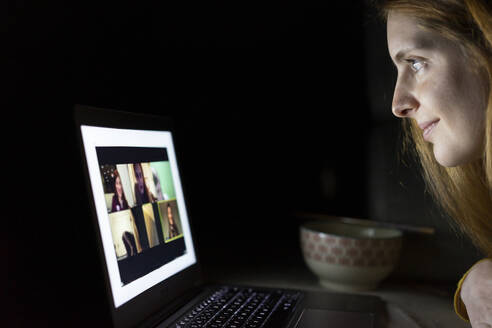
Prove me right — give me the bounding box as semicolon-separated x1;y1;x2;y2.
205;261;471;328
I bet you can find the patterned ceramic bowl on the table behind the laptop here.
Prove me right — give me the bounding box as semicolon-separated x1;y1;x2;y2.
300;221;402;292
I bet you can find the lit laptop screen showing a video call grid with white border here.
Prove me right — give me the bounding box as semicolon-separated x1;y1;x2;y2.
81;125;197;308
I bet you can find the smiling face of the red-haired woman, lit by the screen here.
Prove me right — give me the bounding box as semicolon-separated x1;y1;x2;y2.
387;11;488;167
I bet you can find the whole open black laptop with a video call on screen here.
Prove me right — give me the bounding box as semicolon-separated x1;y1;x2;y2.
74;105;384;328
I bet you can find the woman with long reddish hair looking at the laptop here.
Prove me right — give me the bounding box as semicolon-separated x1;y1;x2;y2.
379;0;492;328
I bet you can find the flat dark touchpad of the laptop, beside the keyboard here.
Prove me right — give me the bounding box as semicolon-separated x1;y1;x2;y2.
297;309;374;328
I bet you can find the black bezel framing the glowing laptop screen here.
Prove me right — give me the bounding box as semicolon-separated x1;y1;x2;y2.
74;105;203;328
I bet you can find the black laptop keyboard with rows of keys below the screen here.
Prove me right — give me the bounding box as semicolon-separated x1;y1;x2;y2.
172;287;300;328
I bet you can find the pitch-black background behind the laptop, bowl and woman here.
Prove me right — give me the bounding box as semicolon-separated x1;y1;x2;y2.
2;0;479;325
